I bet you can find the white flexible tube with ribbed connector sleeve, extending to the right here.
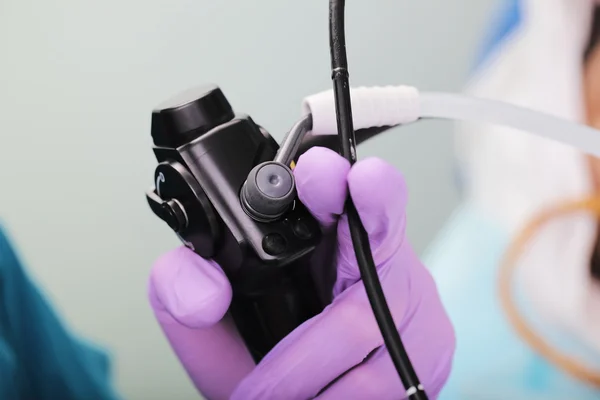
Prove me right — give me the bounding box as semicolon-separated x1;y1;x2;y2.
302;86;600;157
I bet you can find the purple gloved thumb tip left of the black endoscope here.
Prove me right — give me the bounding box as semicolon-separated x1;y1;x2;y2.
149;246;231;328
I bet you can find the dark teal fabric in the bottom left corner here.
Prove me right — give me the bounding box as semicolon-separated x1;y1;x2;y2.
0;225;118;400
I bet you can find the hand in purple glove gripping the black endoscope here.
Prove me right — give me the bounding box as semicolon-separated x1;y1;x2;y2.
149;148;455;400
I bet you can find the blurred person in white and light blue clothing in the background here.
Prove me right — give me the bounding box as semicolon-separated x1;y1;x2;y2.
424;0;600;400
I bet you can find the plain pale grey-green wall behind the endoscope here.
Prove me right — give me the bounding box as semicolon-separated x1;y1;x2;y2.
0;0;494;399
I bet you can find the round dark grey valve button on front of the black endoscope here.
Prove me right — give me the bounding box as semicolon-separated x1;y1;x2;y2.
240;161;296;222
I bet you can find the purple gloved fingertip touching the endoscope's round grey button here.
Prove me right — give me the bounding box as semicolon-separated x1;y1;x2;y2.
294;147;350;225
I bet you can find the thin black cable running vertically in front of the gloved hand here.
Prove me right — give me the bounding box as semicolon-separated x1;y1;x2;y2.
329;0;427;400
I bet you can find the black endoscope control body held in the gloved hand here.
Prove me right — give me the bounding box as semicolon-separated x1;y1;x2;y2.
146;86;335;362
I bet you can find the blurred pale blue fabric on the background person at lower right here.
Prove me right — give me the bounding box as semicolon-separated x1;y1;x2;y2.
423;206;600;400
